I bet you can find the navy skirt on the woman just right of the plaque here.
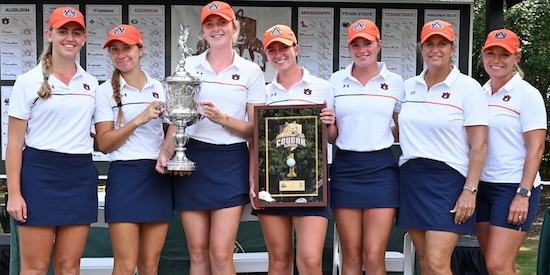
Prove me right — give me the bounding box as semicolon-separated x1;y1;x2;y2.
330;148;399;209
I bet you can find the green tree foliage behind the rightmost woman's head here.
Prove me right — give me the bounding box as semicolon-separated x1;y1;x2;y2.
472;0;550;180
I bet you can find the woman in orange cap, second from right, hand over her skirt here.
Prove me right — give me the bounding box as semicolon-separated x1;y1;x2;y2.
397;20;488;274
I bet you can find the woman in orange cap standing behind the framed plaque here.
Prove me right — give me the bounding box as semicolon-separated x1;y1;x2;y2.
250;25;336;274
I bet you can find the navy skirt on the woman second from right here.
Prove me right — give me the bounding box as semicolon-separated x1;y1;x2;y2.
397;158;476;234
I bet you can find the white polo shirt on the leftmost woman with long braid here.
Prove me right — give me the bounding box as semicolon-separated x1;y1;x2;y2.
8;63;98;154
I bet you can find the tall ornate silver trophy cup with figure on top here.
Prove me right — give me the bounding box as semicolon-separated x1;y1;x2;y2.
164;26;201;171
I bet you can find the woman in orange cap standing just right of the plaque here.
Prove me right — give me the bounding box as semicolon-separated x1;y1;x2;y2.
329;19;403;274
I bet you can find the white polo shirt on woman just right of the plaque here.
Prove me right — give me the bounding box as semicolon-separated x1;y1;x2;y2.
330;62;403;152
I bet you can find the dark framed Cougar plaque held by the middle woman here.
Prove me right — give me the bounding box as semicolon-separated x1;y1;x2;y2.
252;104;328;207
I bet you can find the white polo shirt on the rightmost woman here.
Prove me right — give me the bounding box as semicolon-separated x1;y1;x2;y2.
481;73;547;187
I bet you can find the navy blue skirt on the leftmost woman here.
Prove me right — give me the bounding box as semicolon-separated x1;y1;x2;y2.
16;147;98;226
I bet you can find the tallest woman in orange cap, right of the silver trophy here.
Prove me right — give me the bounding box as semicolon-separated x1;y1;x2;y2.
157;1;265;275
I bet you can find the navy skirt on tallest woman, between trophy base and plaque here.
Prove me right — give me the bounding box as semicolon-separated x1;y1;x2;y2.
174;139;250;210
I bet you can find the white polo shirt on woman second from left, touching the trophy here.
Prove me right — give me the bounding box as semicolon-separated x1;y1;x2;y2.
95;72;168;161
